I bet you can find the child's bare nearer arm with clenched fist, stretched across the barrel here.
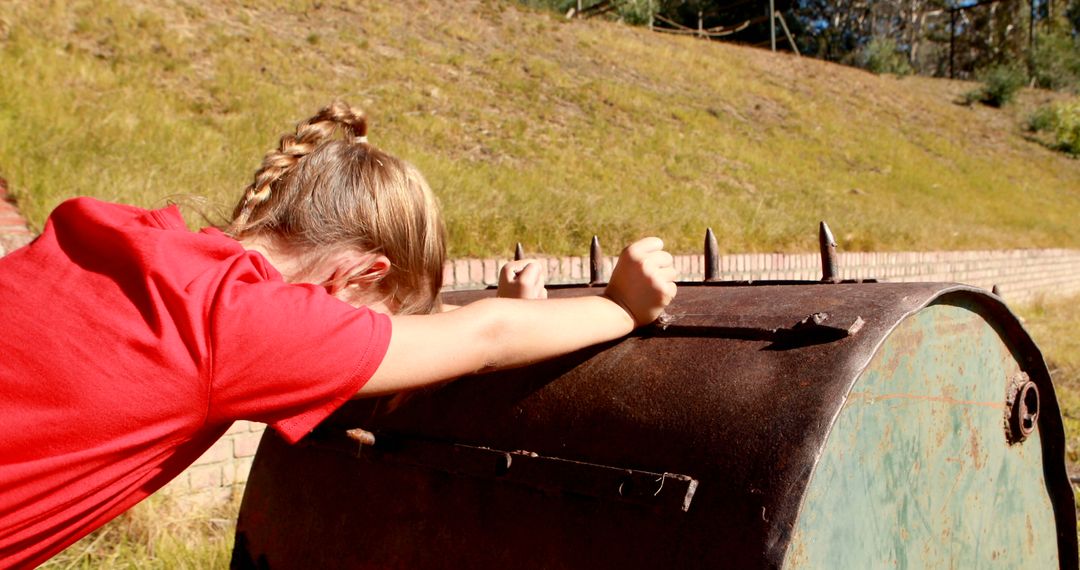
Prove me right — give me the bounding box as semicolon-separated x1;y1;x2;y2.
359;238;675;396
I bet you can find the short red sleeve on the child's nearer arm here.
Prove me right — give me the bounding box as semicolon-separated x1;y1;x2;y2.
207;254;390;443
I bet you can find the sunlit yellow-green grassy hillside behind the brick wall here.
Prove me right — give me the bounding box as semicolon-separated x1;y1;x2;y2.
0;0;1080;256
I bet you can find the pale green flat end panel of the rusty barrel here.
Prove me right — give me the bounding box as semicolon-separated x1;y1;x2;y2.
784;304;1058;569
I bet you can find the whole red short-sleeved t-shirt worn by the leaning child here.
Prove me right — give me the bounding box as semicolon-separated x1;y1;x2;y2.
0;199;390;567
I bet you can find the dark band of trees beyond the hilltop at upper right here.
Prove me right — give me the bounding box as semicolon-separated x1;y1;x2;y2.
529;0;1080;90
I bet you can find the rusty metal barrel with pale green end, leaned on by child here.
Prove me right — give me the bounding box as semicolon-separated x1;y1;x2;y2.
233;282;1078;569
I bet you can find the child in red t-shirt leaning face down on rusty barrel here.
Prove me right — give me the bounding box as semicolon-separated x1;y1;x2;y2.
0;103;675;567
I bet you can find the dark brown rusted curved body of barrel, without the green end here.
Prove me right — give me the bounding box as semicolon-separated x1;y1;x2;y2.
234;280;1077;568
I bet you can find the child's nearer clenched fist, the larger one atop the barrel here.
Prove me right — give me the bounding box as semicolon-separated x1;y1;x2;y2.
604;238;676;326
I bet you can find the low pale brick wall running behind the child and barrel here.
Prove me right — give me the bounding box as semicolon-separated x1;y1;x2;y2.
0;194;1080;504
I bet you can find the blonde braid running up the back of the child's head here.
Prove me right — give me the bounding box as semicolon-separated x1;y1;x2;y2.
228;101;367;236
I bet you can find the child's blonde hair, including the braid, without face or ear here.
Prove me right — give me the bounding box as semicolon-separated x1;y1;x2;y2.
227;101;446;314
